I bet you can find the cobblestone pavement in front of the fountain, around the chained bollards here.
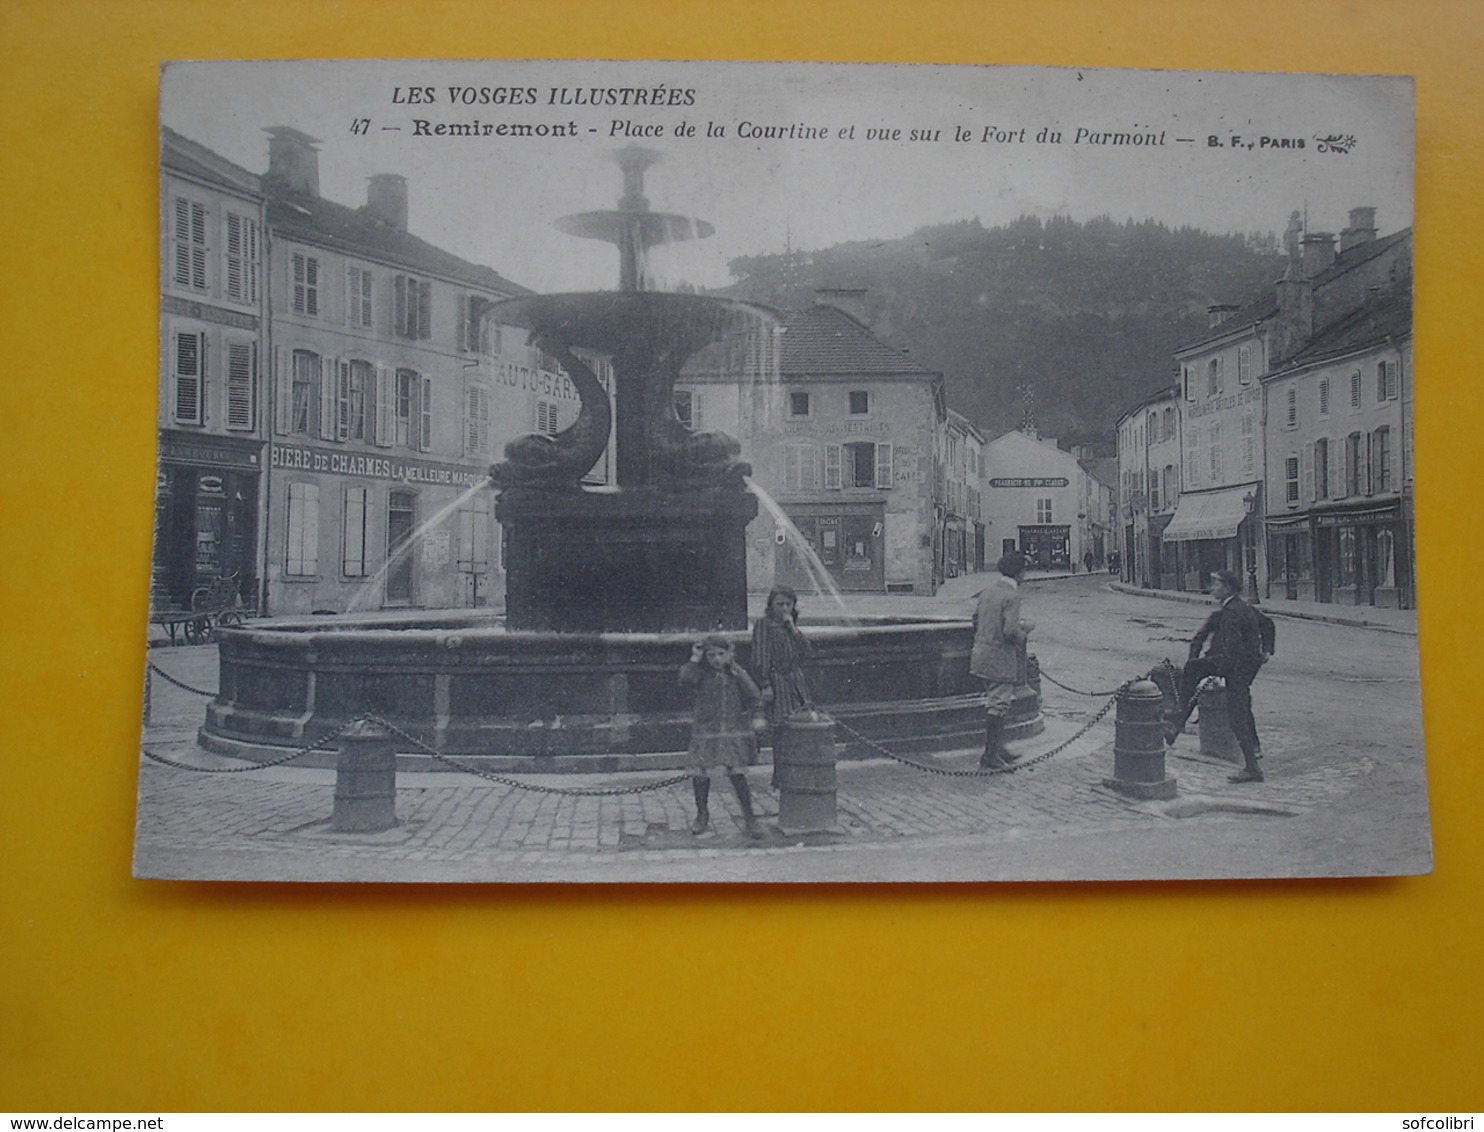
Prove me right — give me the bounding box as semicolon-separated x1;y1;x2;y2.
135;629;1374;881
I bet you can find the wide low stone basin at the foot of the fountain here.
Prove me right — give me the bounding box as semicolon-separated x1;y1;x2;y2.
202;614;1040;771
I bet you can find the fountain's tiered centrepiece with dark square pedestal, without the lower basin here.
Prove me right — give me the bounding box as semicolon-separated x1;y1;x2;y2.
487;147;772;632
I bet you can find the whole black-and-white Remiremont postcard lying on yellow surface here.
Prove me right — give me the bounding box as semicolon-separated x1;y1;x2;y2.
134;59;1431;883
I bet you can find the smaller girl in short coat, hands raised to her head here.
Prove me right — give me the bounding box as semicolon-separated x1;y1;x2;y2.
680;635;767;840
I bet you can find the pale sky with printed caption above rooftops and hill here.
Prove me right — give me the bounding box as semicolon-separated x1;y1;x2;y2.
160;59;1414;291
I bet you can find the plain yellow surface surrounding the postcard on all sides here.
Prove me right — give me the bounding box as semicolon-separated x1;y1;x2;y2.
0;0;1484;1111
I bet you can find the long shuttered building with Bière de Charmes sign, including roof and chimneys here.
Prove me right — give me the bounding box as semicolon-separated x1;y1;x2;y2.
263;128;610;614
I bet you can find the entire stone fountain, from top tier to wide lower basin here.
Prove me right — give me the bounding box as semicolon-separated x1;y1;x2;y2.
200;148;1042;771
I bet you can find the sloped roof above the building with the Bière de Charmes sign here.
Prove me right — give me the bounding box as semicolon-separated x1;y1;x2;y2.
269;190;531;295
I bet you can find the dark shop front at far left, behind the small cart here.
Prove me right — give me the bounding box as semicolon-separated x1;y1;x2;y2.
150;432;263;610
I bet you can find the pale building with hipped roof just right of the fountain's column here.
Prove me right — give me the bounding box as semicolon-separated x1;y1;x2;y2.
675;291;947;593
